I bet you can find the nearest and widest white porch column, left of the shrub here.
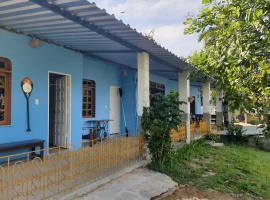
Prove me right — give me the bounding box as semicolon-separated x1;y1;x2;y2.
137;52;150;132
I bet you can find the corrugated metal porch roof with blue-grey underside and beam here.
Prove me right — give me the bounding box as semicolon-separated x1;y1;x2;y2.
0;0;209;79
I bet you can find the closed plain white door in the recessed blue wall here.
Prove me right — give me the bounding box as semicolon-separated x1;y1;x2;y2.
109;86;121;134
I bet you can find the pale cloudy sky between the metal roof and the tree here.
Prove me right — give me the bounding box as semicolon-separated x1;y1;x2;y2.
92;0;202;57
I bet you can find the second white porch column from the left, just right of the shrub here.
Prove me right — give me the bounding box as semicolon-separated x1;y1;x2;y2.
178;71;191;144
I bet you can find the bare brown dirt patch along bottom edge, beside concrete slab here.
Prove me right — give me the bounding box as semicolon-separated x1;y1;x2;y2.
151;186;250;200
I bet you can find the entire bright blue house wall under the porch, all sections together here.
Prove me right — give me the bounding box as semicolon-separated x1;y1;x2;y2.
0;29;200;155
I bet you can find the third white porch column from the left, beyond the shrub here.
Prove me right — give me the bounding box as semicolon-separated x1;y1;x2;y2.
202;81;211;131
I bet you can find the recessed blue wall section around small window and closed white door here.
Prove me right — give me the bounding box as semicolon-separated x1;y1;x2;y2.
83;57;137;134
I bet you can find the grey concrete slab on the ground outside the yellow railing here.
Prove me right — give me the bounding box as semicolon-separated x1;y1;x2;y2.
68;168;177;200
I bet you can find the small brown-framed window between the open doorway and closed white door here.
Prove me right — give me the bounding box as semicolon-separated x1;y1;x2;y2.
82;79;96;118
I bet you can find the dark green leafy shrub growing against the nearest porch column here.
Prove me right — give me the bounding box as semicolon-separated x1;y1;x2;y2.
142;92;183;167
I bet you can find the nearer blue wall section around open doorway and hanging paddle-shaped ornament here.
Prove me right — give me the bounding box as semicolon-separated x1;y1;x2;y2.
0;29;83;149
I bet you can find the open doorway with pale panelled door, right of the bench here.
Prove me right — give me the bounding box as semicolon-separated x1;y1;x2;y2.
49;72;70;148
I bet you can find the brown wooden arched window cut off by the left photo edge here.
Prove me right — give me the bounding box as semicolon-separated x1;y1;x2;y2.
0;57;11;125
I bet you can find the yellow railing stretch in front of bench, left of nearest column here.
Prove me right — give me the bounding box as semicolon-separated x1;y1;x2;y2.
0;136;144;200
